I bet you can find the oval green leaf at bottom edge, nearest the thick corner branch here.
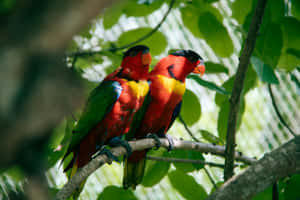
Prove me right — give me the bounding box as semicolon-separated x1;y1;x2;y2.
168;170;207;200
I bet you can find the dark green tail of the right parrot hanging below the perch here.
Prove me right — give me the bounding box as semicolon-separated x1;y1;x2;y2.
123;151;146;189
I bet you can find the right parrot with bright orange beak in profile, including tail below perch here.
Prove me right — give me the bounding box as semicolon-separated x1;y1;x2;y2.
123;50;205;189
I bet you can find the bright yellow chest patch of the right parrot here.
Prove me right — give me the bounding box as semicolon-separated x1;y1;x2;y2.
157;75;185;96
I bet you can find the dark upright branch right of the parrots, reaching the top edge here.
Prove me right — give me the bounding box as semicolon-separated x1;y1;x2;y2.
224;0;267;180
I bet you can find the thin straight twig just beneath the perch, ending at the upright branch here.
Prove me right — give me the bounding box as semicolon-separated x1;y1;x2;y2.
147;156;229;169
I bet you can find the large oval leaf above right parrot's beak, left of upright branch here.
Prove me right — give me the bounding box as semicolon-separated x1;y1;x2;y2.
198;12;233;57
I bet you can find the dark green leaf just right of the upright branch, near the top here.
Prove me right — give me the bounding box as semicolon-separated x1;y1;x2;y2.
255;23;283;69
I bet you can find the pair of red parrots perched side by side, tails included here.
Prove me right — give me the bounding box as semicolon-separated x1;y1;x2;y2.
64;45;205;195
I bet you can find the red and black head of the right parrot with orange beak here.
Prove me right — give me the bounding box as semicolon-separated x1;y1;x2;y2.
151;50;205;82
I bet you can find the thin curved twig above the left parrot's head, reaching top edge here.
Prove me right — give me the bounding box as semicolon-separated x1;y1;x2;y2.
66;0;175;57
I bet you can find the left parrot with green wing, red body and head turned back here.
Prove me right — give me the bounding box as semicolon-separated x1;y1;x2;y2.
63;45;151;195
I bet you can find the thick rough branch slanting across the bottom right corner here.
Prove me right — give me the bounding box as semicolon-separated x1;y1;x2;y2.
206;136;300;200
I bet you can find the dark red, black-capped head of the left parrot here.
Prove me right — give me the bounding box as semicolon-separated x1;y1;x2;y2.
121;45;151;80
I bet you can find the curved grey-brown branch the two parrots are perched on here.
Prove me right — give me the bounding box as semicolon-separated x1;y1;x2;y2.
56;139;256;200
